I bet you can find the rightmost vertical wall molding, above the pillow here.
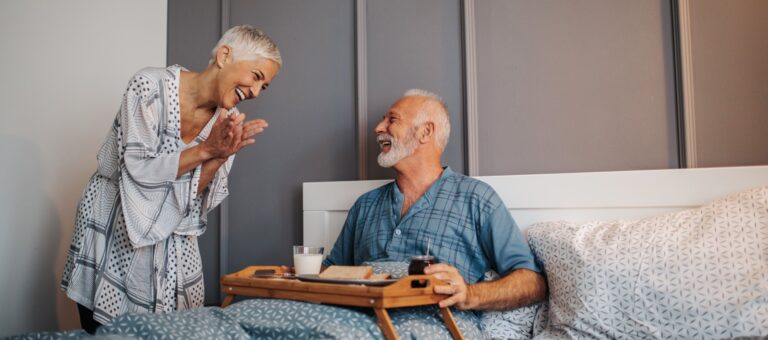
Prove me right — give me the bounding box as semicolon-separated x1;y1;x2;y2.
677;0;698;168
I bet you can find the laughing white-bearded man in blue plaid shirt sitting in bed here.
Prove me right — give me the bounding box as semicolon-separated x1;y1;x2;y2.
324;90;547;332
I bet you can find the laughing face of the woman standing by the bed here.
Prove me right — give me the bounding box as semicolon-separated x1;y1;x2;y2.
216;59;280;110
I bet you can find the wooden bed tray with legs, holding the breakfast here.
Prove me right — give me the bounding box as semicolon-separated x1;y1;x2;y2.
221;266;464;340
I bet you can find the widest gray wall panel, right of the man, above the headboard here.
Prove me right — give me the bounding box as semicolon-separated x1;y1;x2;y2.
475;0;678;175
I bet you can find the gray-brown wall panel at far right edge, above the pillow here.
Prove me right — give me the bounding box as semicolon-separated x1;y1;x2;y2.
690;0;768;167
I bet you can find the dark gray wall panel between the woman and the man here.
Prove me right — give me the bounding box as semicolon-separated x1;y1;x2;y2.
228;0;357;271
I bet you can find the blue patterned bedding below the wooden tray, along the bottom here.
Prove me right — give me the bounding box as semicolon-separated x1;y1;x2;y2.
7;299;484;340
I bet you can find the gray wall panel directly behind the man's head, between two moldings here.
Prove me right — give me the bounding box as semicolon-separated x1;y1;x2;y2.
366;0;465;179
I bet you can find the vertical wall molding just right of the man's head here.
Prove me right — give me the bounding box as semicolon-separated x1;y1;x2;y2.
462;0;480;176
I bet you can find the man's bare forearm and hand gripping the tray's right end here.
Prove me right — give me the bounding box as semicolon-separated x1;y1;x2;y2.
424;264;547;310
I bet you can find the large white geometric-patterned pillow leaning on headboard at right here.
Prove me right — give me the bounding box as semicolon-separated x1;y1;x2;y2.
528;187;768;339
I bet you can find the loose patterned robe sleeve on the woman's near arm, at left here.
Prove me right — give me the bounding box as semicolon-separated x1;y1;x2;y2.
116;72;194;248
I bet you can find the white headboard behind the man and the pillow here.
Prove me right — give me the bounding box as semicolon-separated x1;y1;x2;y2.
303;166;768;254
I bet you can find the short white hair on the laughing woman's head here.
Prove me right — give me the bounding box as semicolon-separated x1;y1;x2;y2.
208;25;283;66
